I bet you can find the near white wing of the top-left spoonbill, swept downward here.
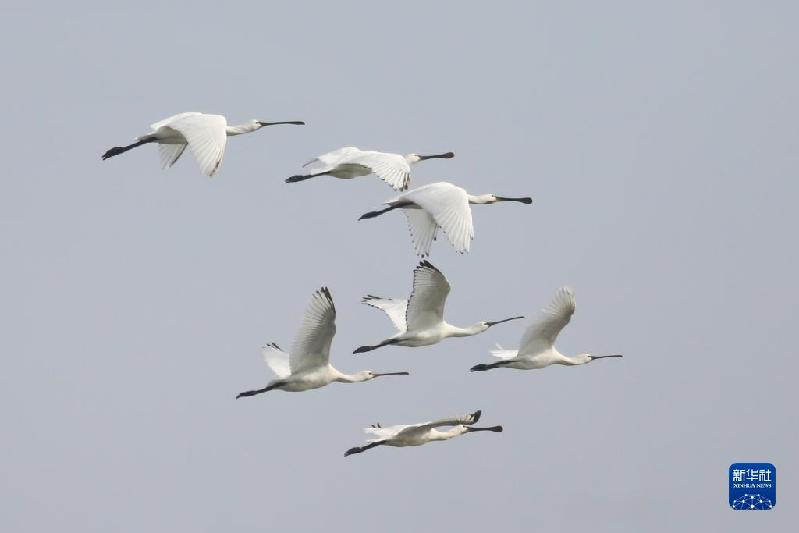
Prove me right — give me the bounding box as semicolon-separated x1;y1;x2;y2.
160;113;227;176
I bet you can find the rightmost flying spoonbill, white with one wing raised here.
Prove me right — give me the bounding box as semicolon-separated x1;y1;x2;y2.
472;287;621;372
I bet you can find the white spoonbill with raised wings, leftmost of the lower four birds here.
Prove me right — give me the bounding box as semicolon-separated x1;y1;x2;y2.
236;287;408;398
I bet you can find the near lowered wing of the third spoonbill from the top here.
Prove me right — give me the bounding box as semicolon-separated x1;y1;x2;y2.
400;182;474;253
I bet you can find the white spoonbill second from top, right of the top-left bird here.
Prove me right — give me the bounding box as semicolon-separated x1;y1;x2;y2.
286;146;455;191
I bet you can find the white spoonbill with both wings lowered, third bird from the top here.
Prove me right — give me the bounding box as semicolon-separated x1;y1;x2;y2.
358;182;533;257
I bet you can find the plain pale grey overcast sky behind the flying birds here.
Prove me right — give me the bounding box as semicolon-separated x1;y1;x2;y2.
0;1;799;533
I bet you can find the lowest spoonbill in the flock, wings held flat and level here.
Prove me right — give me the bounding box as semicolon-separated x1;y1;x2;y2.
344;411;502;457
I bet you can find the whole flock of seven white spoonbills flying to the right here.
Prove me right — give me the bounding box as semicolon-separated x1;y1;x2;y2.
102;112;621;456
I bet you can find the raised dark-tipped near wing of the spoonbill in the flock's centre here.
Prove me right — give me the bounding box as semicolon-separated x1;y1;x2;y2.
405;261;450;331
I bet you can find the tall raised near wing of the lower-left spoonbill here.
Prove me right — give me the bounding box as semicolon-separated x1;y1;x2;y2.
289;287;336;374
